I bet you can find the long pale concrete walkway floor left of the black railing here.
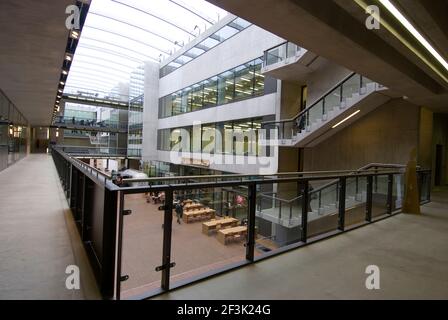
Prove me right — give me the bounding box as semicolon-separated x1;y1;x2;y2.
0;154;99;299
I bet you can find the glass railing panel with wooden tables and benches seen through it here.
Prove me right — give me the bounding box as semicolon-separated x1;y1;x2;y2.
170;187;248;286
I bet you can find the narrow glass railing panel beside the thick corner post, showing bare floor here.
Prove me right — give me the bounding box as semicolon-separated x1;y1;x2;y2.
121;192;164;299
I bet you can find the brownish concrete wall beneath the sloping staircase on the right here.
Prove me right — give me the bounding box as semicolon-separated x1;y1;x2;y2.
304;99;420;171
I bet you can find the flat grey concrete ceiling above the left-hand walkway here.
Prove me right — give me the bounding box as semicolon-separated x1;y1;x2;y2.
0;0;74;125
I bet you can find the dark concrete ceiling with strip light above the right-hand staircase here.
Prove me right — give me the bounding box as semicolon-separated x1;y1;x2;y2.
208;0;448;112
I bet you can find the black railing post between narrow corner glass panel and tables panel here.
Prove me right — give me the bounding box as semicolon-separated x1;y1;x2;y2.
162;189;173;291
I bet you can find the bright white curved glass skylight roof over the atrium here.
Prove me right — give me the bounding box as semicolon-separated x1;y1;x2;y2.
65;0;228;95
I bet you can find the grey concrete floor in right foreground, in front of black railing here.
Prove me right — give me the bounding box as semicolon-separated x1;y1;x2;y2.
157;189;448;299
